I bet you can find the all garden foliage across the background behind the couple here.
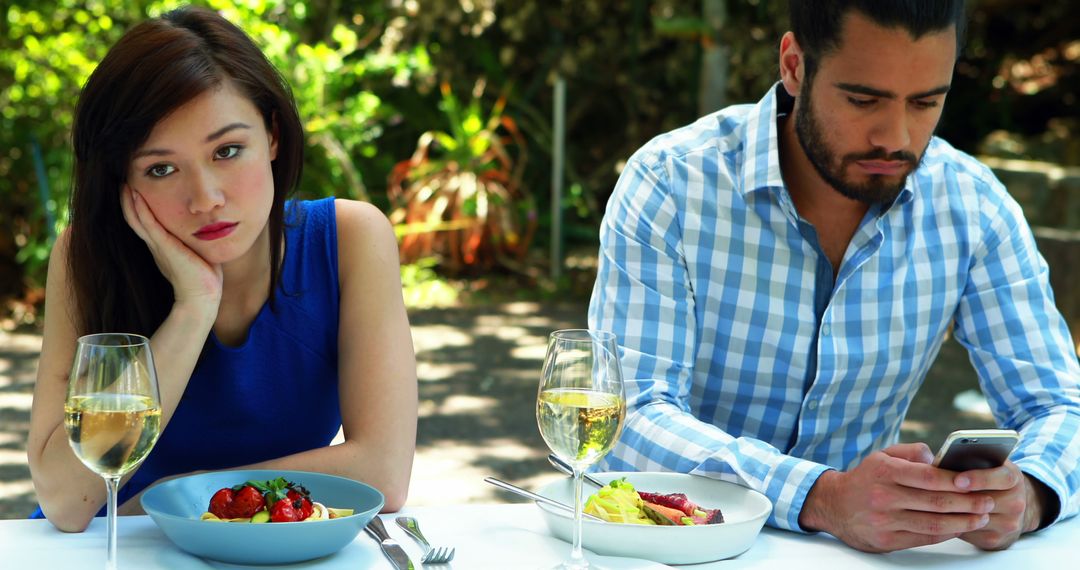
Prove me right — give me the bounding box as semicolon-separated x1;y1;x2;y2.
0;0;1080;306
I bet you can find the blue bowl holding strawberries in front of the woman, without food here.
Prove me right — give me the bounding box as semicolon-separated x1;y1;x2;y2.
140;470;386;565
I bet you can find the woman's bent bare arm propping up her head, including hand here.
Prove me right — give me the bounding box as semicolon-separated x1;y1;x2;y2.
27;191;221;532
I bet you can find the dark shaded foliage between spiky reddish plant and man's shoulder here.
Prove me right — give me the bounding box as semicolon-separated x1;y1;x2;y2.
382;0;786;241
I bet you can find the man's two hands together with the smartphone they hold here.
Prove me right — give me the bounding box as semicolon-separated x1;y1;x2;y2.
799;431;1042;552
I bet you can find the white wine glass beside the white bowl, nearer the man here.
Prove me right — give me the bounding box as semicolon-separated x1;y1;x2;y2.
537;329;626;569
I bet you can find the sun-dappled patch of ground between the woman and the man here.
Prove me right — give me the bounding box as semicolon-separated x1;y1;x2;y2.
408;302;585;505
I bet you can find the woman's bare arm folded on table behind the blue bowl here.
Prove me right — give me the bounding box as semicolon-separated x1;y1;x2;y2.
168;200;417;512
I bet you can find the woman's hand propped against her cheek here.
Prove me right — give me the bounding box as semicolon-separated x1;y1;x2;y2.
120;185;222;312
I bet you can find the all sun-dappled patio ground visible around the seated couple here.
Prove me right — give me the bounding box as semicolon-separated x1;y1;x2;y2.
0;301;993;518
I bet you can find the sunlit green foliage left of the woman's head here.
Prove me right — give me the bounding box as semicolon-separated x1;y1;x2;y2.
0;0;133;294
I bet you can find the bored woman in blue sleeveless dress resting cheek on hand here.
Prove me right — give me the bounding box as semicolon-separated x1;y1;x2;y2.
28;8;417;531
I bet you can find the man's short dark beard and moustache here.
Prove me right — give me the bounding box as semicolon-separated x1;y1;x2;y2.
795;78;929;205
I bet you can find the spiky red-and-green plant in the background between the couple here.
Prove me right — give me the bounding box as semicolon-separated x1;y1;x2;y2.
388;81;536;271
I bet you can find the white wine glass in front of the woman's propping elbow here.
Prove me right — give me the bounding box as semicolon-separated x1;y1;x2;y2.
64;333;161;569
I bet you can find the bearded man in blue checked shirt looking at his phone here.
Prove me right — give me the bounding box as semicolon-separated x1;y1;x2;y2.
590;0;1080;552
